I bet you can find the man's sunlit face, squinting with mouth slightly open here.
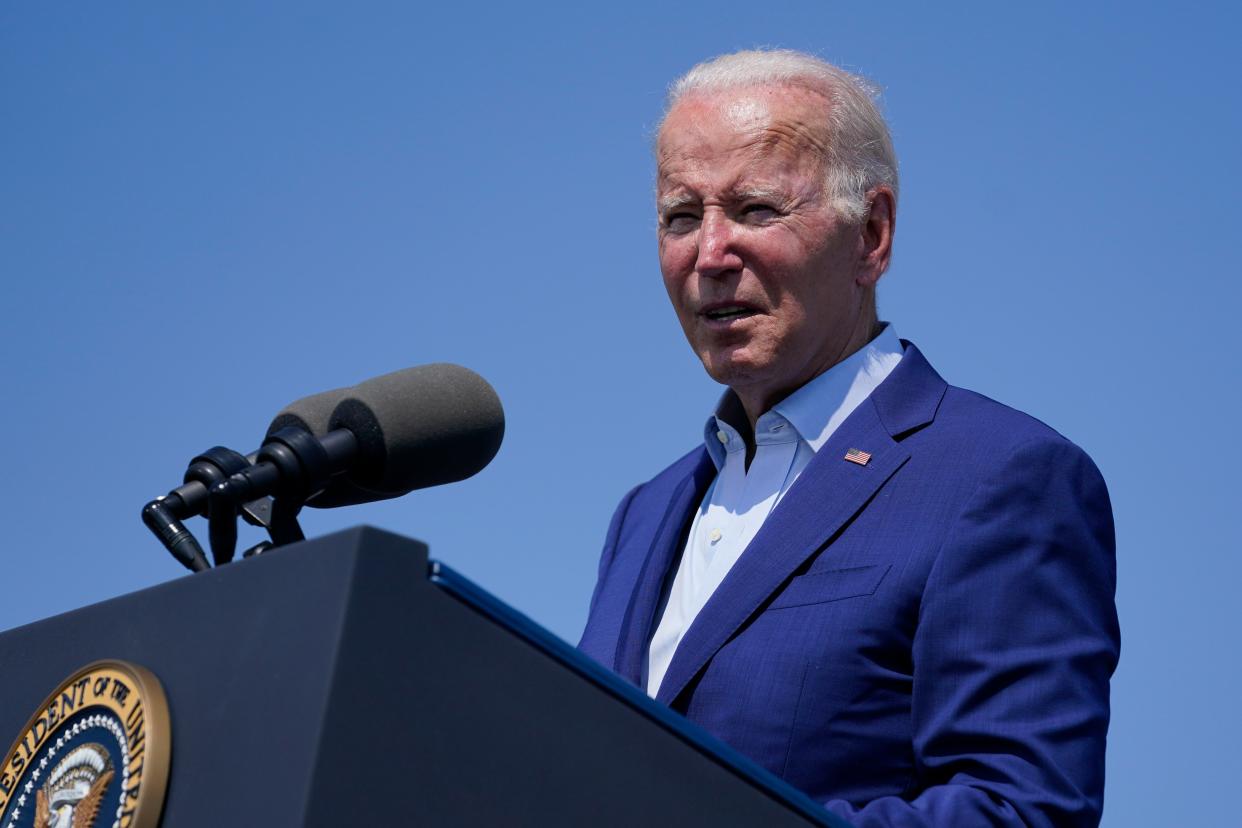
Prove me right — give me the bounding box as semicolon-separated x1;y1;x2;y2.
656;87;887;418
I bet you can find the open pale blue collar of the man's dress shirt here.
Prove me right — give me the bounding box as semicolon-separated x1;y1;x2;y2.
703;323;902;469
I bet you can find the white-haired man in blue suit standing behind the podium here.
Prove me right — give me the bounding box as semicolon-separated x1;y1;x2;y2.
581;52;1118;828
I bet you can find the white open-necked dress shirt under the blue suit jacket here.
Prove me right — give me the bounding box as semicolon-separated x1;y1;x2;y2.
647;324;902;696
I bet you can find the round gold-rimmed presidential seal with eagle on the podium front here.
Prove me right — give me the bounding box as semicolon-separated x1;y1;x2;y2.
0;662;170;828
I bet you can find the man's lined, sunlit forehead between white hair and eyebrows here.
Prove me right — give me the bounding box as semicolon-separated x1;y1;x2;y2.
656;86;828;191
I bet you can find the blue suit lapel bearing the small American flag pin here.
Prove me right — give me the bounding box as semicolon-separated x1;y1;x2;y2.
655;345;948;705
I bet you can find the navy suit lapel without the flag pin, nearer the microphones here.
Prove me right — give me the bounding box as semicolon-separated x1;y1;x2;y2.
615;449;715;684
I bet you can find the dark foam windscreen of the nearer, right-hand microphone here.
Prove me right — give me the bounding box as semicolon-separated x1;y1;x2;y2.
327;362;504;505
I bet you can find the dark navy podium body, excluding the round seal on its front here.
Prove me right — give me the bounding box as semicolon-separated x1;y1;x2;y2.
0;528;846;828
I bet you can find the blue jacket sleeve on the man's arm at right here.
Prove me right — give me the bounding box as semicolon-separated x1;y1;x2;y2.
827;436;1120;828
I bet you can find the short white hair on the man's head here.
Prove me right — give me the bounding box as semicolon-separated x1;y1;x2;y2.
661;48;897;221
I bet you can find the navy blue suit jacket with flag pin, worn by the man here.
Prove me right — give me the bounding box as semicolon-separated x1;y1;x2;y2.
580;344;1119;828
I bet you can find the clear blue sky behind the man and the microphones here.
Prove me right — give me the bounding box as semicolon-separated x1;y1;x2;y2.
0;1;1242;826
